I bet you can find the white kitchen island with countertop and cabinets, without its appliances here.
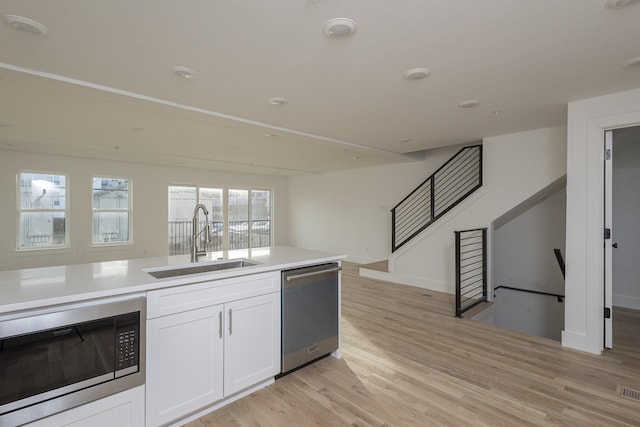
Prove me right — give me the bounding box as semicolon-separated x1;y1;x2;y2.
0;247;344;427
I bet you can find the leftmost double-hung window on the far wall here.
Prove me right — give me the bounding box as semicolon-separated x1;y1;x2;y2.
18;172;69;250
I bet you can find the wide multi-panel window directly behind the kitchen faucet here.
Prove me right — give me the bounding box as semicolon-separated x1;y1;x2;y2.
168;186;271;255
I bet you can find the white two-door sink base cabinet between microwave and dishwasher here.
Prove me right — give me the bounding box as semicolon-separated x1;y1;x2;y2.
146;272;281;426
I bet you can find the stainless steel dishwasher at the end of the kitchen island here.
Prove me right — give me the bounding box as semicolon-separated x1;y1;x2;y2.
282;262;341;374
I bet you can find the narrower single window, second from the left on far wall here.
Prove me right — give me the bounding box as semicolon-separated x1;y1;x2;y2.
92;177;131;245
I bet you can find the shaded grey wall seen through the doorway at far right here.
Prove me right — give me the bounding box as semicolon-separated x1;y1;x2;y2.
611;127;640;310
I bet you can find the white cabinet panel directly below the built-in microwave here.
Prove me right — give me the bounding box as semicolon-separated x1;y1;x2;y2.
27;385;144;427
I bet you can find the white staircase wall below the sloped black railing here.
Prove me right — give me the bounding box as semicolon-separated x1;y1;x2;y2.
390;126;566;293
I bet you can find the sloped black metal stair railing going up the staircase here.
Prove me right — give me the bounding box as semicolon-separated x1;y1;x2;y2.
391;145;482;252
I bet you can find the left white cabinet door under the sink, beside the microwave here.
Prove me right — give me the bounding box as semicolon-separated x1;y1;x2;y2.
146;305;223;426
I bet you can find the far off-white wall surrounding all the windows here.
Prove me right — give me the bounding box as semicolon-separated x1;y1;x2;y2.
0;150;289;270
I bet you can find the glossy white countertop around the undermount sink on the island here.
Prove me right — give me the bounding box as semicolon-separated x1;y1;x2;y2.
0;246;346;313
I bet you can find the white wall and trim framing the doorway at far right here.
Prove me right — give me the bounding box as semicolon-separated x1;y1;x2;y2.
562;89;640;354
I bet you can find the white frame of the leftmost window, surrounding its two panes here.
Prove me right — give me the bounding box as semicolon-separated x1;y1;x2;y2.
15;169;71;253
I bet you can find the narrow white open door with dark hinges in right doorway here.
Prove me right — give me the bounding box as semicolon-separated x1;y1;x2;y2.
602;130;614;348
